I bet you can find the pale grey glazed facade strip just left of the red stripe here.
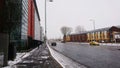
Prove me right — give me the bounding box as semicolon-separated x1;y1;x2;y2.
21;0;28;47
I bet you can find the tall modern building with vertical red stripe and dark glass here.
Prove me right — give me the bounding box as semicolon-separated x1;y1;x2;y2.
0;0;41;65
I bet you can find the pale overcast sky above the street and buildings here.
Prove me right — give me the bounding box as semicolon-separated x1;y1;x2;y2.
37;0;120;38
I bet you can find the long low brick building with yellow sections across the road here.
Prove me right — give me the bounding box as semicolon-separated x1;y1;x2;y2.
66;26;120;43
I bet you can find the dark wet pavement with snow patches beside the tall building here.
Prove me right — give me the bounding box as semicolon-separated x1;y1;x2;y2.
3;45;62;68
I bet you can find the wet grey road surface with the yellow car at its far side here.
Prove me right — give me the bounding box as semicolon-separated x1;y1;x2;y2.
53;43;120;68
